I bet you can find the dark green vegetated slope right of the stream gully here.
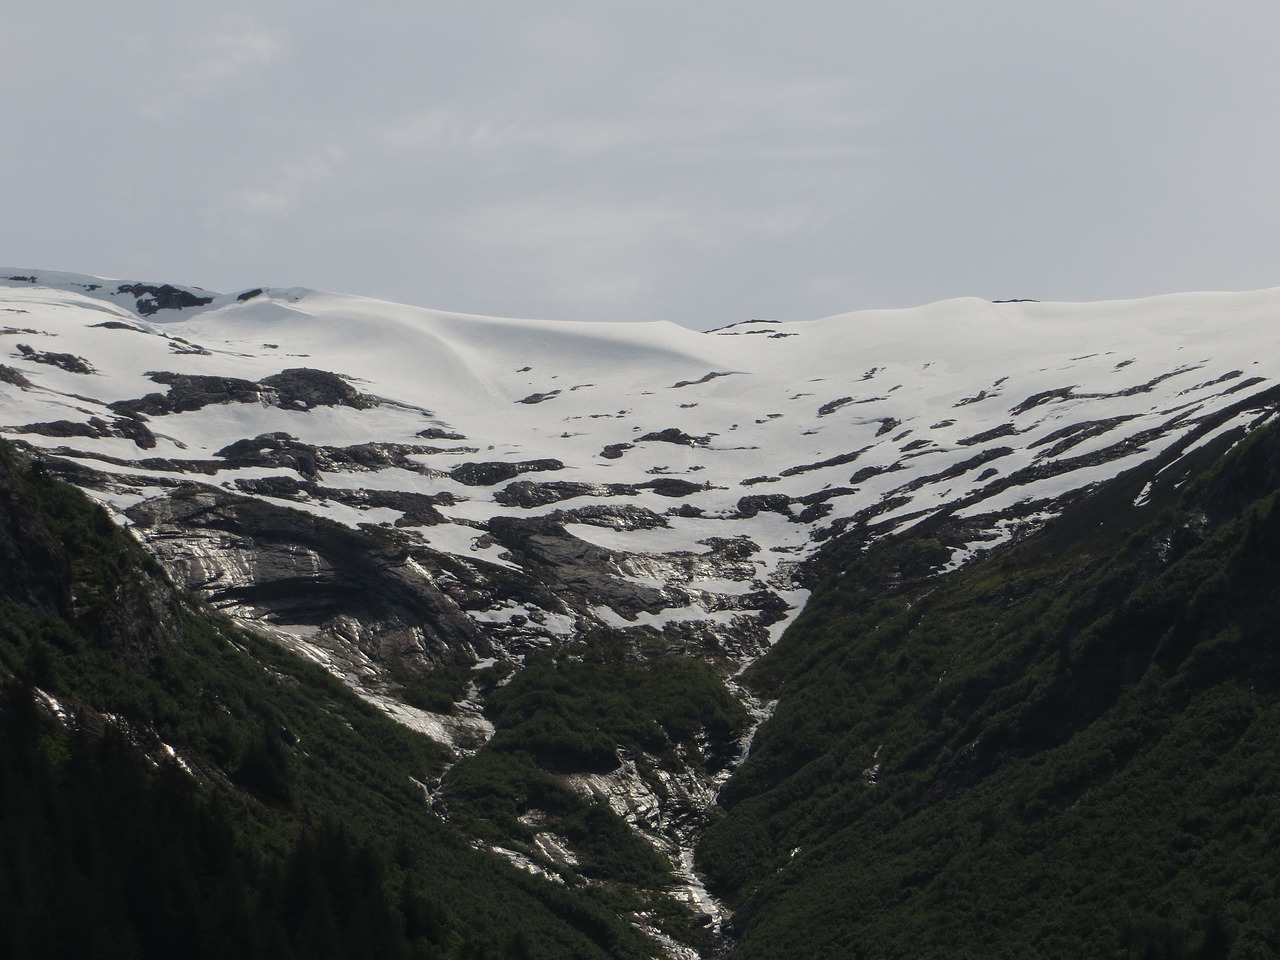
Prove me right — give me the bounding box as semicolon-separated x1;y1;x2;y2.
698;430;1280;960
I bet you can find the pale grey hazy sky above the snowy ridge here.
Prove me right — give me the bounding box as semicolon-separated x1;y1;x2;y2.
0;0;1280;329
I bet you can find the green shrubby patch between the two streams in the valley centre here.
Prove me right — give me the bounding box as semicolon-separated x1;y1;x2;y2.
443;637;748;938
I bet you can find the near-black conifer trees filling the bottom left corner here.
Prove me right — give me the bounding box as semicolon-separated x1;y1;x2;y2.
0;686;455;957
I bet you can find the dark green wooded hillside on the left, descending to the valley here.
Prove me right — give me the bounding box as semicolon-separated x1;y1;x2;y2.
0;445;653;959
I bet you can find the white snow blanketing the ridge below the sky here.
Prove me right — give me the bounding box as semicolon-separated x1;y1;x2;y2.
0;271;1280;660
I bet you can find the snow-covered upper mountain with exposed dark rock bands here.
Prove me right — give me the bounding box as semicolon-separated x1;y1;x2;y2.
0;270;1280;686
